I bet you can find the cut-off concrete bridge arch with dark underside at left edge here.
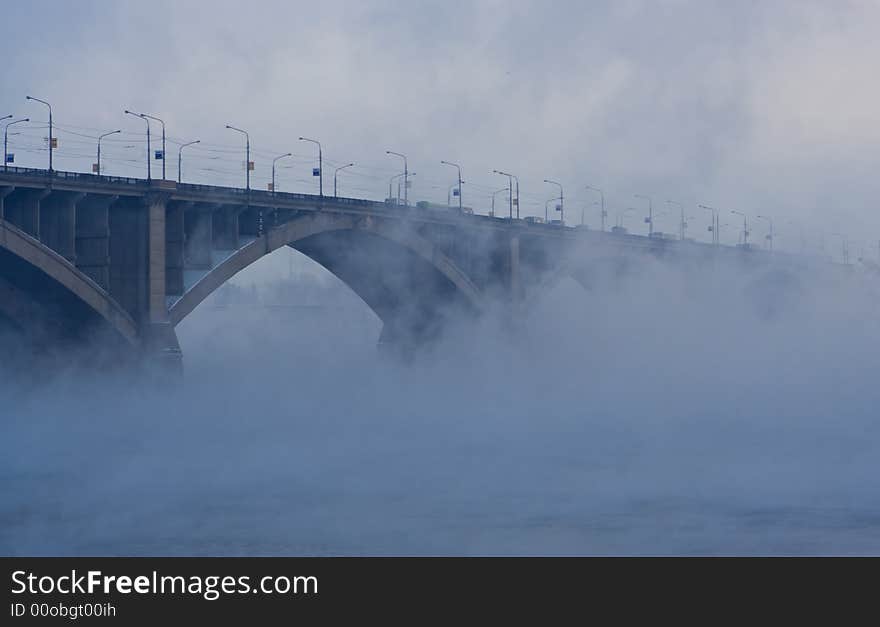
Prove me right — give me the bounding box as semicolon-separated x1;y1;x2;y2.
0;220;140;346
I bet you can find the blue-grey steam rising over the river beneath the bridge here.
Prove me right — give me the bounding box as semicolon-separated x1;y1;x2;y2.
0;253;880;555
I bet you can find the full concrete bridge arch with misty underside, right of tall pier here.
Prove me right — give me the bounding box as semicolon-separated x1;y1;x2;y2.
169;212;482;339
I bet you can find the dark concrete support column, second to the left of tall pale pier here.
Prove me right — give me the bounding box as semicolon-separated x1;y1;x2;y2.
74;194;119;290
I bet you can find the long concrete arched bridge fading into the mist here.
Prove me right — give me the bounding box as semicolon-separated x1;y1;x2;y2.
0;167;820;372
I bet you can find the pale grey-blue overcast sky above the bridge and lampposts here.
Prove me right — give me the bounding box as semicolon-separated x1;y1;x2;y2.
0;0;880;255
